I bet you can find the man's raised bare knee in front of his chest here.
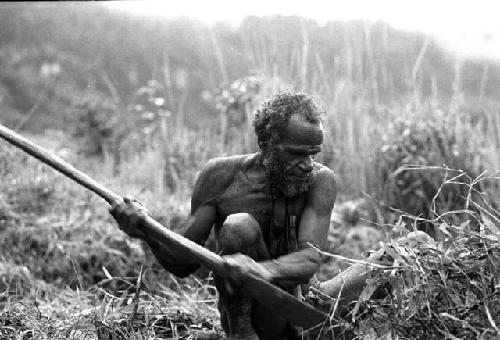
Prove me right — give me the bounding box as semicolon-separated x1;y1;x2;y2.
218;213;262;255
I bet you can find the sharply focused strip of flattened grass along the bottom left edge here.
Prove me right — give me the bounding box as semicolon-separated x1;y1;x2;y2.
0;263;221;339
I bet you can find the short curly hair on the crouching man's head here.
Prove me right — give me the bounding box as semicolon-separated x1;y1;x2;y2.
252;92;325;148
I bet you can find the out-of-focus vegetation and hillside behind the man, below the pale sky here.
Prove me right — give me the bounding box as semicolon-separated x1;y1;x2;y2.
0;3;500;338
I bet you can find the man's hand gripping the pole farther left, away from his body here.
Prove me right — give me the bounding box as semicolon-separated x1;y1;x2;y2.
109;197;149;240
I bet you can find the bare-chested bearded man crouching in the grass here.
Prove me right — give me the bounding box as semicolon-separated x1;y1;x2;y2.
112;93;336;339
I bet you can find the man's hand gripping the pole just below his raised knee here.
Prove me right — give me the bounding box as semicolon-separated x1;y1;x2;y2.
223;254;273;285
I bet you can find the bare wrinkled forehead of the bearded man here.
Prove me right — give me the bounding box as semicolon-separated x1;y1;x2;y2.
281;115;323;145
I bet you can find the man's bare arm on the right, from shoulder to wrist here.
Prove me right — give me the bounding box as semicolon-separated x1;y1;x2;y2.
261;167;337;286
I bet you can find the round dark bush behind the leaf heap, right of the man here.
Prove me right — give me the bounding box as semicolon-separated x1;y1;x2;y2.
374;112;485;232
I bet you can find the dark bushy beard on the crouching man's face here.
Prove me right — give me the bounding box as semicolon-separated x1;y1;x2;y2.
262;150;312;197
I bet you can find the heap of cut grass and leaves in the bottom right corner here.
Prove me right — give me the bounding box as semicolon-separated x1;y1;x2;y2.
353;224;500;339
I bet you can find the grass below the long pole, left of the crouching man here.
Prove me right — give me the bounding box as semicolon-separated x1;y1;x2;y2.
0;142;221;339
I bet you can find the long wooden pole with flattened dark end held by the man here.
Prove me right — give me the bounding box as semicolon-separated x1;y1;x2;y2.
0;124;328;329
